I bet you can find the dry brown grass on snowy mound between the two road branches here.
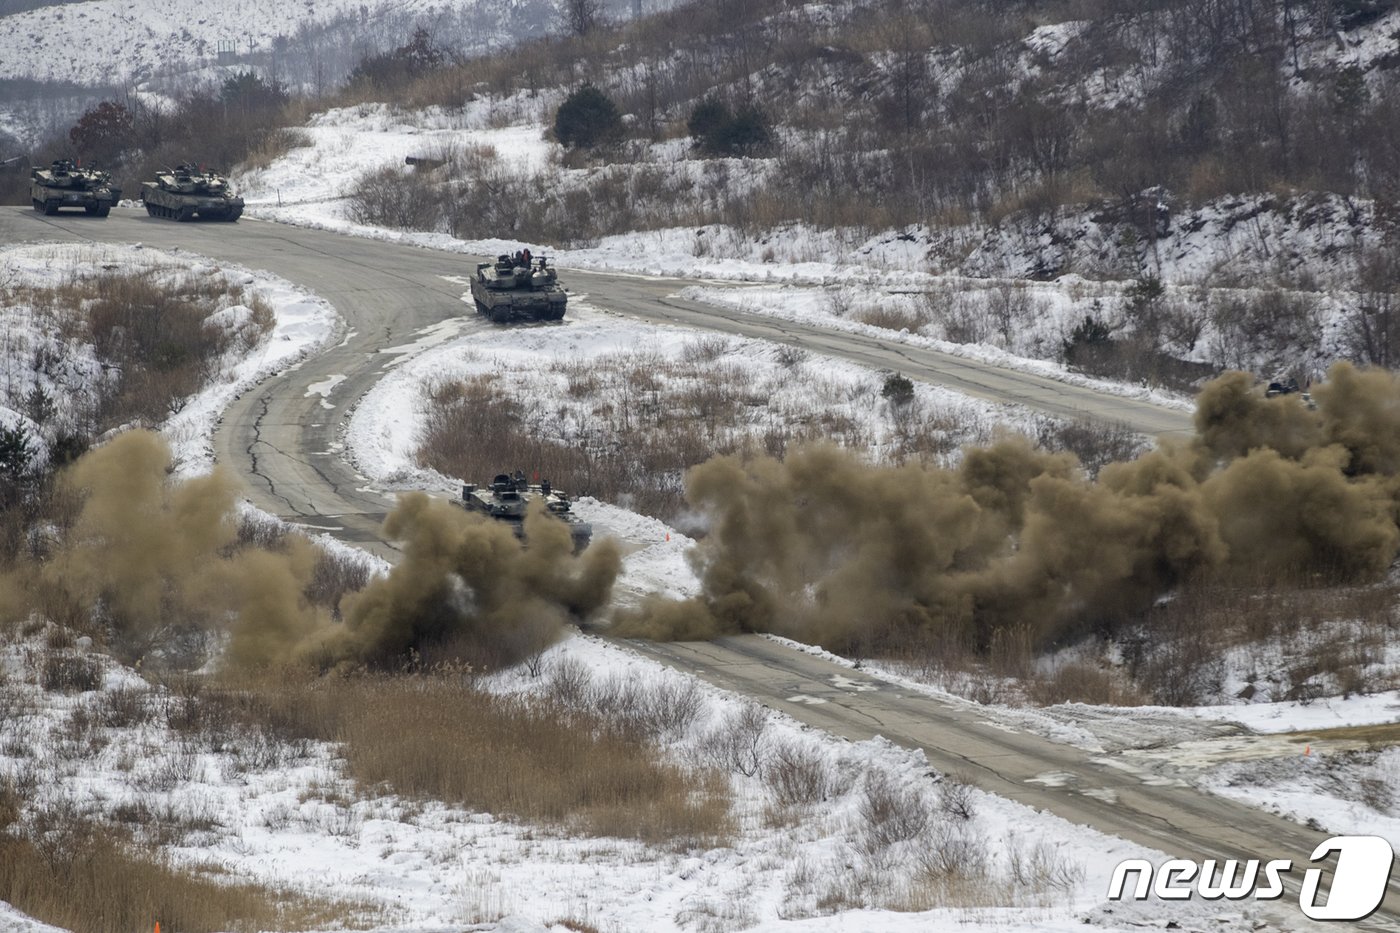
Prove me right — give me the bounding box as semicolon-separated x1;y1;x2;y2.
417;338;974;521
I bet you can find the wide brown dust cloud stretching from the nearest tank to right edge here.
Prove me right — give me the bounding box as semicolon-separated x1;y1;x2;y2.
616;364;1400;651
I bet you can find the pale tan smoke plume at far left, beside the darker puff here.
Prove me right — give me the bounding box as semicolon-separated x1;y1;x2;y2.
3;431;331;664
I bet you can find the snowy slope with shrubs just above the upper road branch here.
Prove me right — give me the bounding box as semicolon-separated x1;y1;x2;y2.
237;94;1379;395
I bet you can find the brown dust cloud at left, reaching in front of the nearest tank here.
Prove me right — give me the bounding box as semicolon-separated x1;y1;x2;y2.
0;431;620;668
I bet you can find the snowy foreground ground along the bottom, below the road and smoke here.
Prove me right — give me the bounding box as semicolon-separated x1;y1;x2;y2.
0;616;1282;933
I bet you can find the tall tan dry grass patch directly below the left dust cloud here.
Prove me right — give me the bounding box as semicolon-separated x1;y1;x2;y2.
217;672;729;846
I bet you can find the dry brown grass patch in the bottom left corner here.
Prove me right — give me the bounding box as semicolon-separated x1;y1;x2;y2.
0;814;374;933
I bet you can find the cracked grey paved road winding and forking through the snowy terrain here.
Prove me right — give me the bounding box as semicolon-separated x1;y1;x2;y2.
0;209;1400;930
